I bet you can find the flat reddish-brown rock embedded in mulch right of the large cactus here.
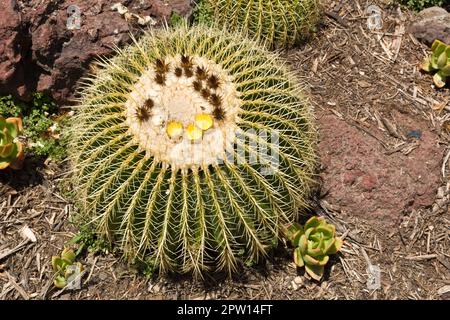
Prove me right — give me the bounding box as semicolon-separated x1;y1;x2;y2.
319;114;443;225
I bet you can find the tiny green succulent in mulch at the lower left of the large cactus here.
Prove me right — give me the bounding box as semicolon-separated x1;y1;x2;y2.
52;248;83;289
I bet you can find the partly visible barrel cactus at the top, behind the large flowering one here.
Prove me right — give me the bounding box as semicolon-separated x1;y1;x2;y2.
204;0;320;47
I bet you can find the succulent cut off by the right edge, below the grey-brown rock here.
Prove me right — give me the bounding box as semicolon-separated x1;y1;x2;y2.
422;40;450;88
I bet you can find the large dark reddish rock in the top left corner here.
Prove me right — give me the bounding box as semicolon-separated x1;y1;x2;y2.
0;0;192;103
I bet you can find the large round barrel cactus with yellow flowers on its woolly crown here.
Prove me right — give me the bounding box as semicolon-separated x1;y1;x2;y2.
70;26;316;274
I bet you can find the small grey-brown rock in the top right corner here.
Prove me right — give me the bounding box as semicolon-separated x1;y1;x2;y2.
409;7;450;45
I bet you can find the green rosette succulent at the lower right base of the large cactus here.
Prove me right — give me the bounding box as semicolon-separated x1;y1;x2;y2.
285;216;342;281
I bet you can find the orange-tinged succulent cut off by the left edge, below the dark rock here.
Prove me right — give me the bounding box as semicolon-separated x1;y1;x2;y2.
0;116;24;170
